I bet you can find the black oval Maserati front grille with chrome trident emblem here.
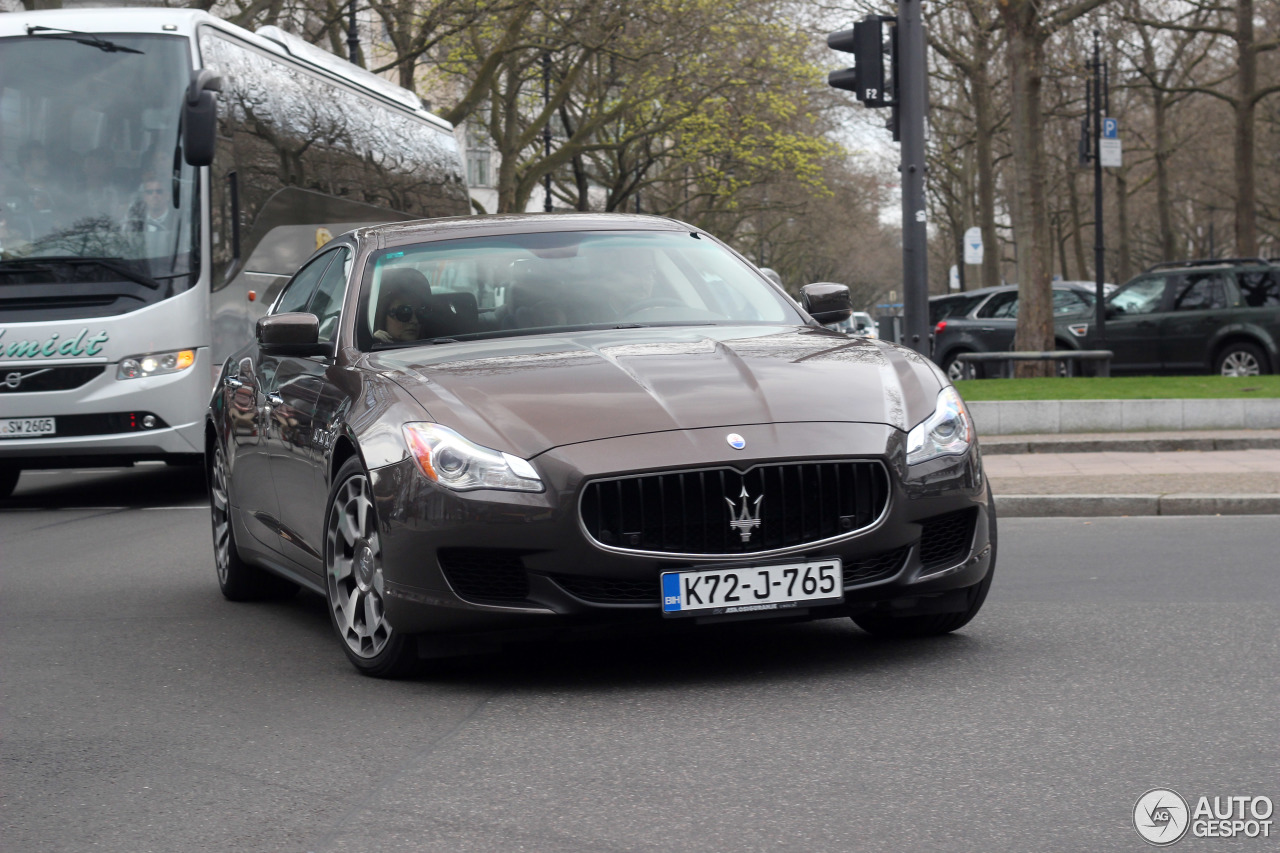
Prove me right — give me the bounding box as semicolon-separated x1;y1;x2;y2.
580;460;888;555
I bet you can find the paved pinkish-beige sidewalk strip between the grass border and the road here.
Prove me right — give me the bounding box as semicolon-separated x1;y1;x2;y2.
979;429;1280;517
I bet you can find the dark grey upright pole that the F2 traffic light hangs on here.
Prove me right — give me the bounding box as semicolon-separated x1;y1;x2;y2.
895;0;933;356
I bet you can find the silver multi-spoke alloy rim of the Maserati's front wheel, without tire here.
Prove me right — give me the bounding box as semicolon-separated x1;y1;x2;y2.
324;474;392;658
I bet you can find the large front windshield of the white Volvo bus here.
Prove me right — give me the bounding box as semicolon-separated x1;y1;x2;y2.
0;28;200;292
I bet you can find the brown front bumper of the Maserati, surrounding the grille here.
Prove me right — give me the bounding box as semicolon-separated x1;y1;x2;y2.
371;423;995;633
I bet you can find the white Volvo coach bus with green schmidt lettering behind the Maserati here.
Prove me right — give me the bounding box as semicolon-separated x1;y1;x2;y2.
0;9;470;497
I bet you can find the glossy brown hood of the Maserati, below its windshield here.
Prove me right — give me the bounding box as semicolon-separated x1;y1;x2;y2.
367;325;943;459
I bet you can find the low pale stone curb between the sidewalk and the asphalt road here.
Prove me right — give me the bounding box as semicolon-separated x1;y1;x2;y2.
996;493;1280;519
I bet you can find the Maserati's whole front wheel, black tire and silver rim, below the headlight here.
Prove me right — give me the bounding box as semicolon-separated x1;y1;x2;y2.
324;457;419;679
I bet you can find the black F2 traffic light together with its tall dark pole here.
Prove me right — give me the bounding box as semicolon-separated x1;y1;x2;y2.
827;0;933;356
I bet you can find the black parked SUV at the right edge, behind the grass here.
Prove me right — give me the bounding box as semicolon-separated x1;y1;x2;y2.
1057;259;1280;377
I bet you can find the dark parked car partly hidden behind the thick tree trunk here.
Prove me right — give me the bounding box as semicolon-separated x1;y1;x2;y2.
931;282;1094;382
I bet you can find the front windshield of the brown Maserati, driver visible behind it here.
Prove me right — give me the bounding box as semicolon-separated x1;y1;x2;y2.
361;232;804;346
